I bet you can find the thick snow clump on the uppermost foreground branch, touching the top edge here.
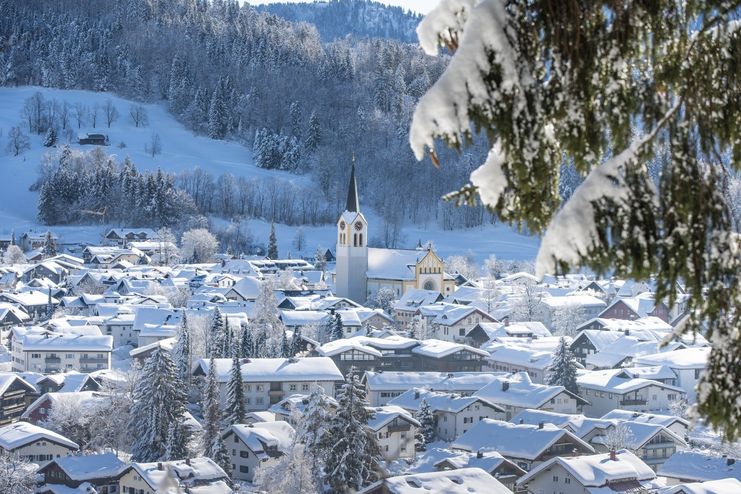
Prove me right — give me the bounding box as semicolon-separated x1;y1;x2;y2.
409;0;519;160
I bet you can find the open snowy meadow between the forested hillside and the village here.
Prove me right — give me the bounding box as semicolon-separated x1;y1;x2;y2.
0;87;539;261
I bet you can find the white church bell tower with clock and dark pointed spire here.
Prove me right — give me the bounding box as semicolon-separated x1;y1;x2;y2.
335;157;368;304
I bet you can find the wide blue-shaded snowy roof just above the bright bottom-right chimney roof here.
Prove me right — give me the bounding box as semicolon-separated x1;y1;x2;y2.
453;418;594;460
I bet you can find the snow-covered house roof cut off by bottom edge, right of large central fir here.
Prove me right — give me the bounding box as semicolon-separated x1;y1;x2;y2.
358;468;511;494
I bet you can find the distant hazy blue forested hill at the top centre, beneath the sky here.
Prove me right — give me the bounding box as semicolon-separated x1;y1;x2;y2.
256;0;420;43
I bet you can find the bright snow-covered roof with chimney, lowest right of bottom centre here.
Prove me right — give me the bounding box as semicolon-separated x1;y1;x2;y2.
517;449;656;487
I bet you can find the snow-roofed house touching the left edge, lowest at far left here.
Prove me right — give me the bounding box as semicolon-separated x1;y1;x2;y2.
0;422;80;467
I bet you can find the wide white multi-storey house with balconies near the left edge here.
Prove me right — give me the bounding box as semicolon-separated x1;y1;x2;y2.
11;328;113;374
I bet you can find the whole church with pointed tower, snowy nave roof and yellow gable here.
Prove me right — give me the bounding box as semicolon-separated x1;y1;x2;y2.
335;161;455;304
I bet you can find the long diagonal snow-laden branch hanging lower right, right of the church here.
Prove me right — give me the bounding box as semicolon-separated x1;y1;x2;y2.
535;103;680;278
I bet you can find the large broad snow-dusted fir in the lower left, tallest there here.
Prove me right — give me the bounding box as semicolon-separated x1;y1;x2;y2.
128;349;186;462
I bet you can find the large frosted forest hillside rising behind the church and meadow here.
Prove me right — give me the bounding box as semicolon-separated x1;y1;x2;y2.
0;0;489;236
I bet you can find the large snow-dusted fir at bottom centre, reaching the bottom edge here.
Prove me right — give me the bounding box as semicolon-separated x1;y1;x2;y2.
323;368;380;492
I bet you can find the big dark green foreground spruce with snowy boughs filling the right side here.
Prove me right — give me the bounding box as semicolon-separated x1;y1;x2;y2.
409;0;741;440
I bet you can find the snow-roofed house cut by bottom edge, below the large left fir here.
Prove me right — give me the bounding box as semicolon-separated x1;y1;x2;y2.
119;458;232;494
